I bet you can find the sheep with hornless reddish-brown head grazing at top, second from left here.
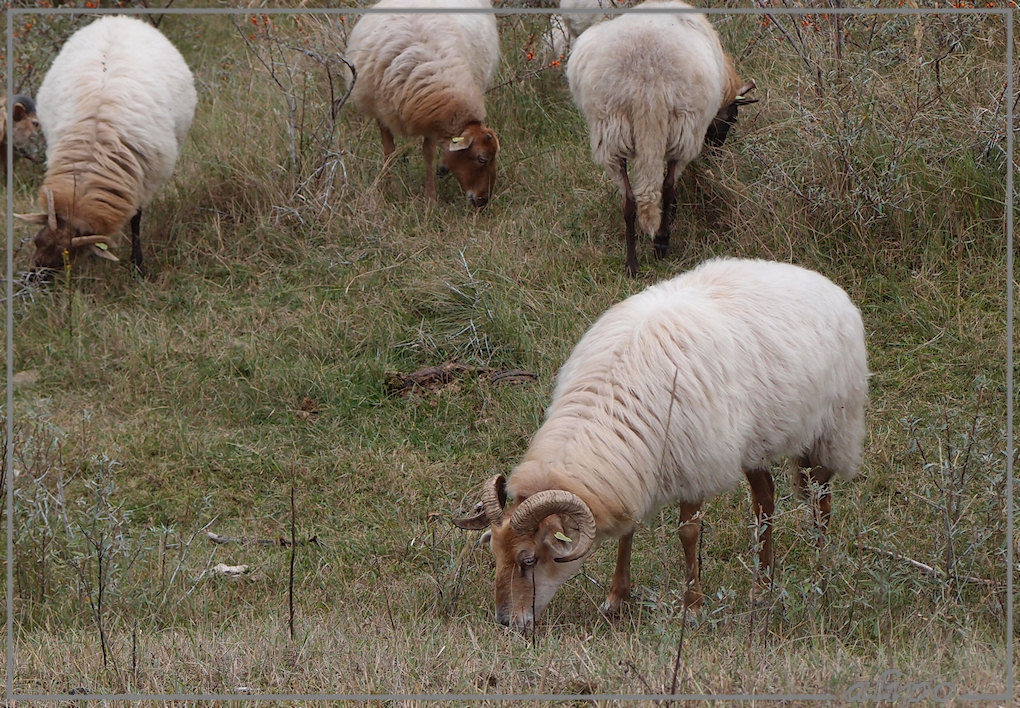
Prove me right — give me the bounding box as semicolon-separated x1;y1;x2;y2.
347;0;500;207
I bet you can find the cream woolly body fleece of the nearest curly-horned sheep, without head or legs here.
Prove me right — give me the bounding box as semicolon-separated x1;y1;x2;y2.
508;259;868;535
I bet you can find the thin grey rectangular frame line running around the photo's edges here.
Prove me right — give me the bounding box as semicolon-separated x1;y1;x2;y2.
4;7;1014;703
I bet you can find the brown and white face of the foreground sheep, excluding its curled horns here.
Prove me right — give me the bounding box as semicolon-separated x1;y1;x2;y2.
490;515;582;629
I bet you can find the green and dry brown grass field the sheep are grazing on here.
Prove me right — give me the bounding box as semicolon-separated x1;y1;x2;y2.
3;2;1006;695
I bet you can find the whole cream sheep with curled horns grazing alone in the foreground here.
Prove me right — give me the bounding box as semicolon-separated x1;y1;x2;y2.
454;258;869;627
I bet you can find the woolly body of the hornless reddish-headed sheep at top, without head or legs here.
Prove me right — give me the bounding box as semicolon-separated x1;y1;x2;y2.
347;0;499;139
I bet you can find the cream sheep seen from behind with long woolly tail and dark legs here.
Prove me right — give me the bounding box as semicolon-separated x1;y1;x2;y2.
566;0;755;276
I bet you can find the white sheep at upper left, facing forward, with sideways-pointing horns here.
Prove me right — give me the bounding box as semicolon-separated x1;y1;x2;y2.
19;16;197;273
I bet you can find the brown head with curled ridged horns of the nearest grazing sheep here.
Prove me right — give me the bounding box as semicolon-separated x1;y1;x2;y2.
454;474;596;628
